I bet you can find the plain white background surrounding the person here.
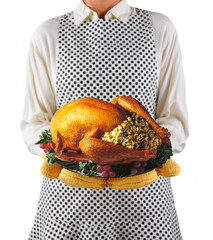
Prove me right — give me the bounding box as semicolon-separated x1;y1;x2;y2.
0;0;213;240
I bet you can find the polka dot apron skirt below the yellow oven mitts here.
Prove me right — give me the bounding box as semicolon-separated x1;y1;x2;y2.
29;176;182;240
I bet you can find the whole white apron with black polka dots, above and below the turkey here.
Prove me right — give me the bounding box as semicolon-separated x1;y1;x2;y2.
29;8;182;240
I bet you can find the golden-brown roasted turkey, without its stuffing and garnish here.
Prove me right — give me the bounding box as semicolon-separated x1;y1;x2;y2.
50;96;170;165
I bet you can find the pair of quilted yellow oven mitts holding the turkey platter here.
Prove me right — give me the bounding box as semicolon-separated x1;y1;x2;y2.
40;153;180;190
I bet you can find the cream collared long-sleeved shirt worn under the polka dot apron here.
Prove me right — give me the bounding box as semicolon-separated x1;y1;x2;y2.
20;0;189;156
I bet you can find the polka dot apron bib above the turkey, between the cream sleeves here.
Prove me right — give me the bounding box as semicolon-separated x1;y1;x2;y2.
56;9;157;117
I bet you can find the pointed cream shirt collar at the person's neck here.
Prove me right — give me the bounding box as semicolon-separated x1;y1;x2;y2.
73;0;131;26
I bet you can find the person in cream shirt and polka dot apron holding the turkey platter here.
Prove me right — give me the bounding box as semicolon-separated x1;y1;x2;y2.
21;0;189;237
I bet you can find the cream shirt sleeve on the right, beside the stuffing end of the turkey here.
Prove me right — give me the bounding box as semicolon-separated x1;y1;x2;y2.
151;14;189;153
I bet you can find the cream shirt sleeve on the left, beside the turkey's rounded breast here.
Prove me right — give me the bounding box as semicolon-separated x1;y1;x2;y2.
20;22;56;156
